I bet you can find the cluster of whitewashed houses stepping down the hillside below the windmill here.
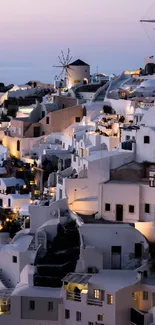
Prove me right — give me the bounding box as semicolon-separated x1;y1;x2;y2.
0;59;155;325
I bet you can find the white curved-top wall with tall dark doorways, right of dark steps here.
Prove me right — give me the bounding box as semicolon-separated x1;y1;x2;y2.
79;224;149;271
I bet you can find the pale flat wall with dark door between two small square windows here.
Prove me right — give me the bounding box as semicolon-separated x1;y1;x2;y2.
99;181;140;223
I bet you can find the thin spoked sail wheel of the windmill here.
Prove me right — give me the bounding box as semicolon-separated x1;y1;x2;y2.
53;48;72;84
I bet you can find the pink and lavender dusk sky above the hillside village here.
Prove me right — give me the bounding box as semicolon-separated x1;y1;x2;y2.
0;0;155;84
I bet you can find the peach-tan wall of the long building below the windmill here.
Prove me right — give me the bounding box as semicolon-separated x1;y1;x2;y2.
40;105;83;134
